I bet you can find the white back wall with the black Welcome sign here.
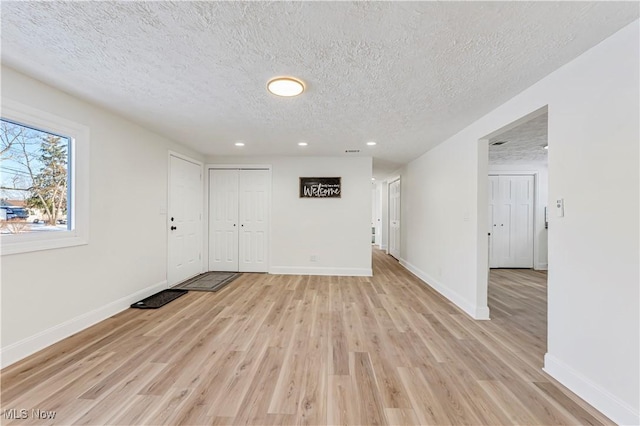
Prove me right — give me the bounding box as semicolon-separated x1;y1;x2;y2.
207;157;372;275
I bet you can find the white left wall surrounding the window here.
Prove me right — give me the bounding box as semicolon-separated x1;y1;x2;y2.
1;67;198;366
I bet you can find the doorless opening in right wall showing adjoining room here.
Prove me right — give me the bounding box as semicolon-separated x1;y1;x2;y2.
478;106;548;326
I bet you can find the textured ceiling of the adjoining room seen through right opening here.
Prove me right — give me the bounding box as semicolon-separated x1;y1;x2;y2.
489;113;548;164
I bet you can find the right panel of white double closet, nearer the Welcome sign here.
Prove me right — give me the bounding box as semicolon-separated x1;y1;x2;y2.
239;170;270;272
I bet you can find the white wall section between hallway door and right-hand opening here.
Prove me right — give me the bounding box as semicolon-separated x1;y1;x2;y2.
400;135;488;319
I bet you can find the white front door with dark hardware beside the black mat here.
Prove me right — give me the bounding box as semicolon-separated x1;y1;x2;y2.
167;155;202;286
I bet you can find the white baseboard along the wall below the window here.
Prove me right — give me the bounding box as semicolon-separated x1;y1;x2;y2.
0;281;167;368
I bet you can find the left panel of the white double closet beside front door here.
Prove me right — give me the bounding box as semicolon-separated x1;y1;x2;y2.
209;170;240;272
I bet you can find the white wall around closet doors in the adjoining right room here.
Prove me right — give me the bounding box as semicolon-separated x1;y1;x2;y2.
489;164;549;270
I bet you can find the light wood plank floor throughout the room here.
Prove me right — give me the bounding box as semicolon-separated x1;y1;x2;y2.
1;251;610;425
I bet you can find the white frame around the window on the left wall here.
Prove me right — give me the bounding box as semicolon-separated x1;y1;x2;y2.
0;98;90;256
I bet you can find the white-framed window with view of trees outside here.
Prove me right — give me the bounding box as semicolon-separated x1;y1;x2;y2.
0;99;89;255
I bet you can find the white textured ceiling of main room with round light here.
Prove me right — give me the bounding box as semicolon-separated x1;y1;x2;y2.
1;1;638;176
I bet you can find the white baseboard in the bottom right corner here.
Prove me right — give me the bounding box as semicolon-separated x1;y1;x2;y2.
543;353;640;425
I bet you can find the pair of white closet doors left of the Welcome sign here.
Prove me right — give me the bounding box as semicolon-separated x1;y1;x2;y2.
209;169;271;272
